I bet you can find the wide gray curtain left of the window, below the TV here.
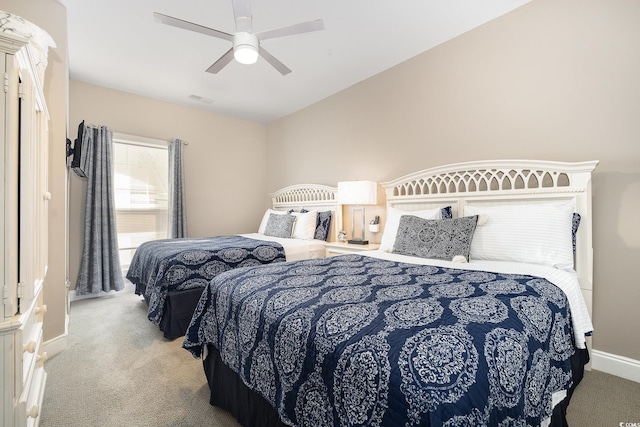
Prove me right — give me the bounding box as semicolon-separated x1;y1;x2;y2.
76;125;124;295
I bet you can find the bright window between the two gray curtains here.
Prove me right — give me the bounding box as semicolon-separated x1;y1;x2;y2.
113;133;169;269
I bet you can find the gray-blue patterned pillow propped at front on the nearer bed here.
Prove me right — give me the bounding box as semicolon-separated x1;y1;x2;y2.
393;215;478;261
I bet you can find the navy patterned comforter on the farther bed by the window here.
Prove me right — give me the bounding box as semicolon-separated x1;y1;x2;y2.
127;236;286;325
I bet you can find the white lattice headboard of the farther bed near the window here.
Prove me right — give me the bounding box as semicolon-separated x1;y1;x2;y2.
270;184;342;242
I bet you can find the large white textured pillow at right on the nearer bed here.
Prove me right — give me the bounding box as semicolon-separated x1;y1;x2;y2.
464;203;574;269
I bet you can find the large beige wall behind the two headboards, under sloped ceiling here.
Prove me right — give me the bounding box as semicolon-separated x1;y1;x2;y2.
267;0;640;360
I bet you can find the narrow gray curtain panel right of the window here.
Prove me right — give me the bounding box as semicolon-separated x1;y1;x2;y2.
168;139;187;239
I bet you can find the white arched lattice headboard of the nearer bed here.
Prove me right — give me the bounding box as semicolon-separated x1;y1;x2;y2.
382;160;598;320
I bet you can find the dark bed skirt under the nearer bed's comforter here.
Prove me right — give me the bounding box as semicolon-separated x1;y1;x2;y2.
202;345;589;427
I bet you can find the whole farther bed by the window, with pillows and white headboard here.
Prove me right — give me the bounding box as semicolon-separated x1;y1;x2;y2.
126;184;340;339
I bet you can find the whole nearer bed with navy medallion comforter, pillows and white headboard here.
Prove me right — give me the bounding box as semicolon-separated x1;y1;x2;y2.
183;160;597;426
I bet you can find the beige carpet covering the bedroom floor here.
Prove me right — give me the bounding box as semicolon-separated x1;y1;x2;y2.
40;286;640;427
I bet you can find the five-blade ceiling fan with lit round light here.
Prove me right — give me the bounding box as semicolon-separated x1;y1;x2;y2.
153;0;324;76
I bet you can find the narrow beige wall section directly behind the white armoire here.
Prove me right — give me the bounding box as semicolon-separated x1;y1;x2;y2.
0;0;69;341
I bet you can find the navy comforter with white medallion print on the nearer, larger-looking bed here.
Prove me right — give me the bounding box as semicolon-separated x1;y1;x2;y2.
183;255;574;427
